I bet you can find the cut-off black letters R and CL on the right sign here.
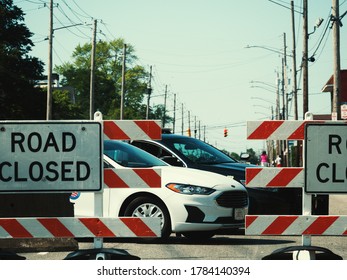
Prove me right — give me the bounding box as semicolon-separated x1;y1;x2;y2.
316;134;347;183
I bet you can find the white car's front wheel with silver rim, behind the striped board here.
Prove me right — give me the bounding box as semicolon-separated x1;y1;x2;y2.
124;196;171;239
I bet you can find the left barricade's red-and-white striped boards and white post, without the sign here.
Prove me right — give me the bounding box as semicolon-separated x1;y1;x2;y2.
0;112;161;260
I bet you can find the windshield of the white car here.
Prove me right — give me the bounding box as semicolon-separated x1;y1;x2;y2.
104;140;167;168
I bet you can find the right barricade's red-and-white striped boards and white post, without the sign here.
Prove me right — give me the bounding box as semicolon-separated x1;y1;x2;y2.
245;113;347;259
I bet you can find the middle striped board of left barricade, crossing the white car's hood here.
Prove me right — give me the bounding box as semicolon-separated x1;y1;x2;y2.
104;168;161;188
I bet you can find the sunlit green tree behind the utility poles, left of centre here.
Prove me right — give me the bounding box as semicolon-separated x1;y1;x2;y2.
55;39;148;119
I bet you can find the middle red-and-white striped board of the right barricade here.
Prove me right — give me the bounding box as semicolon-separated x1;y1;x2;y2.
246;167;305;188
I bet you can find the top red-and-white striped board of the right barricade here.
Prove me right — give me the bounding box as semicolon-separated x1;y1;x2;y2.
247;120;346;140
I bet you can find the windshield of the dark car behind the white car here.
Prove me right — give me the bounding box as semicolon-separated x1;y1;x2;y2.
161;137;237;164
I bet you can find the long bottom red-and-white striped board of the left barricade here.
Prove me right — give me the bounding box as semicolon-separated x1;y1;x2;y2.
0;217;161;239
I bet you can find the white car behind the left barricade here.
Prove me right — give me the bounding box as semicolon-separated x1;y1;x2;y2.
73;140;248;238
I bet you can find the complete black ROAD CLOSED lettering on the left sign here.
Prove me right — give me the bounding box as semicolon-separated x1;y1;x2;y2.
0;131;91;185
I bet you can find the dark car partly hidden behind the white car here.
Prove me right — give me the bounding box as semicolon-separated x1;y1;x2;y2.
131;133;302;215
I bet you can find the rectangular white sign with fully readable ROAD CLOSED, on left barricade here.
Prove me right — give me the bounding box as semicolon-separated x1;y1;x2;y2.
0;121;103;192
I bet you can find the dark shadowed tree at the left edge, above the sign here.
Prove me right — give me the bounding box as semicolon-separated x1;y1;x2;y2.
0;0;45;119
